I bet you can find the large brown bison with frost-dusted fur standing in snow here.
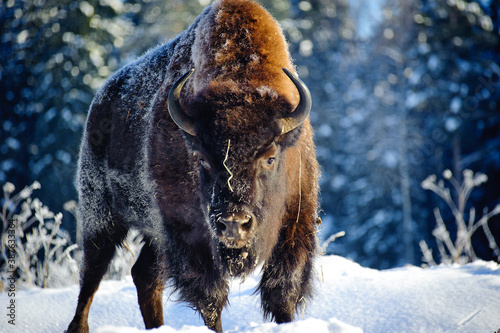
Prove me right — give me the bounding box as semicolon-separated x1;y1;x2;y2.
68;0;320;332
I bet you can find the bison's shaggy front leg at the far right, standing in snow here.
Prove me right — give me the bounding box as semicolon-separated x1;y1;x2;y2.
259;218;317;323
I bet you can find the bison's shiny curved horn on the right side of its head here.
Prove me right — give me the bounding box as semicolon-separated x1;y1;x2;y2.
280;68;312;134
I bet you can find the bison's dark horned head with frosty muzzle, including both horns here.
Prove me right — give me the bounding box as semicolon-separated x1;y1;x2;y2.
168;69;311;262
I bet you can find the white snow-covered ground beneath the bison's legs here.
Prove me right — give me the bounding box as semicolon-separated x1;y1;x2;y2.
0;256;500;333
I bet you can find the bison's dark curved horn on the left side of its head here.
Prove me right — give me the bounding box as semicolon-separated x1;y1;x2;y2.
167;68;196;136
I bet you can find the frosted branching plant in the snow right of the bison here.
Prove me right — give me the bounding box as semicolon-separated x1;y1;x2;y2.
420;169;500;266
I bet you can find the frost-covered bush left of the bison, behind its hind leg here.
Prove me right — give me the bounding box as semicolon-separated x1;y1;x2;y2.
0;182;78;288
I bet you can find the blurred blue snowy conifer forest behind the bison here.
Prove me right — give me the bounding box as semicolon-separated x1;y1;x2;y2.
0;0;500;269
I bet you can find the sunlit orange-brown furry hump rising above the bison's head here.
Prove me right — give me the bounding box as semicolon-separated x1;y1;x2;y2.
188;0;298;107
